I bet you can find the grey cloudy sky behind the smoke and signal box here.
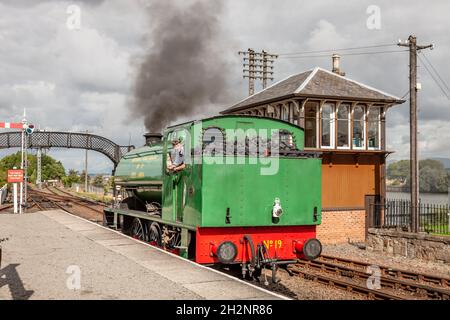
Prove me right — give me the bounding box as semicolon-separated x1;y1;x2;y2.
0;0;450;172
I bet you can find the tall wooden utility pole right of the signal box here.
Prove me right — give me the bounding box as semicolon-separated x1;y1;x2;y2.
398;35;433;232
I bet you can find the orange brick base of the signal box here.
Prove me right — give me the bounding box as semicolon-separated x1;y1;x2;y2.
317;210;366;244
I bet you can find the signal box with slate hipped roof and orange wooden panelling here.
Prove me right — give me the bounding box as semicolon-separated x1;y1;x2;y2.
222;62;405;243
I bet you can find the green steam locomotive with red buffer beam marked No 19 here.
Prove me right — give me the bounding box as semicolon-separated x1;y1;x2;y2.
104;115;322;277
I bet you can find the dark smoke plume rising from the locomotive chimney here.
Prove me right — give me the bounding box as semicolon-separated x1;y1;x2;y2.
132;1;226;132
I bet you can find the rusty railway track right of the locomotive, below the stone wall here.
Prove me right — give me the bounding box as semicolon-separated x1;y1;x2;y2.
289;255;450;300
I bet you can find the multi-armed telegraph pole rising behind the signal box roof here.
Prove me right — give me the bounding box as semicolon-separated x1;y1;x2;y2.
239;49;278;96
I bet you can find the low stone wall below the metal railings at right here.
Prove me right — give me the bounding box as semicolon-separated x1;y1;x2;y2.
367;229;450;264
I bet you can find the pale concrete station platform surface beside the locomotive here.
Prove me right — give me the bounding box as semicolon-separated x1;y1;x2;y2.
0;210;284;300
